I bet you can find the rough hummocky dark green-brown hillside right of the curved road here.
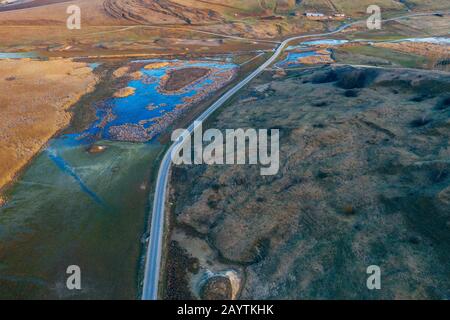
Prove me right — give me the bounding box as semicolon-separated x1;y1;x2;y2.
168;66;450;299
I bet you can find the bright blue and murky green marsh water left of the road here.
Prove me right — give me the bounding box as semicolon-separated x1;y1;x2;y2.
0;61;235;299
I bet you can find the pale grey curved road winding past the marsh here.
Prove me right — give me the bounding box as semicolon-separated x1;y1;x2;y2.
142;12;447;300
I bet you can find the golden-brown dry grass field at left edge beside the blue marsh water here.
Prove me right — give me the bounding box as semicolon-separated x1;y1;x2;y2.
0;59;97;195
